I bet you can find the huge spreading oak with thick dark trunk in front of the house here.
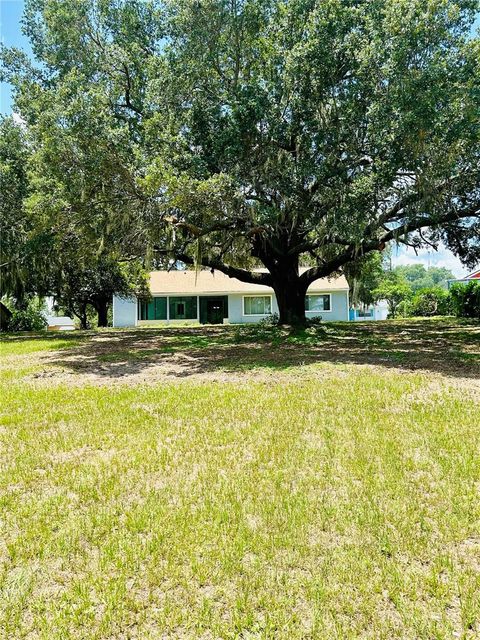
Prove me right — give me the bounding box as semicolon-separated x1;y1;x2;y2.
6;0;480;324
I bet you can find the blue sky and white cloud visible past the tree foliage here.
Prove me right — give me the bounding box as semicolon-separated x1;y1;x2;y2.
0;0;480;276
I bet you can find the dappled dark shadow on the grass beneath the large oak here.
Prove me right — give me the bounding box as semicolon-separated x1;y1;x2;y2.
27;319;480;383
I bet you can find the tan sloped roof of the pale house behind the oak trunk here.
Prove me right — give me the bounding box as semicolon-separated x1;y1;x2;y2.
150;269;348;295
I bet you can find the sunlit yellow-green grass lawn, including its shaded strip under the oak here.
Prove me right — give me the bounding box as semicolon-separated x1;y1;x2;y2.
0;319;480;640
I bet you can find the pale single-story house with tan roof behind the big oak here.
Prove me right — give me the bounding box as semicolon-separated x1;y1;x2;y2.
113;270;349;327
